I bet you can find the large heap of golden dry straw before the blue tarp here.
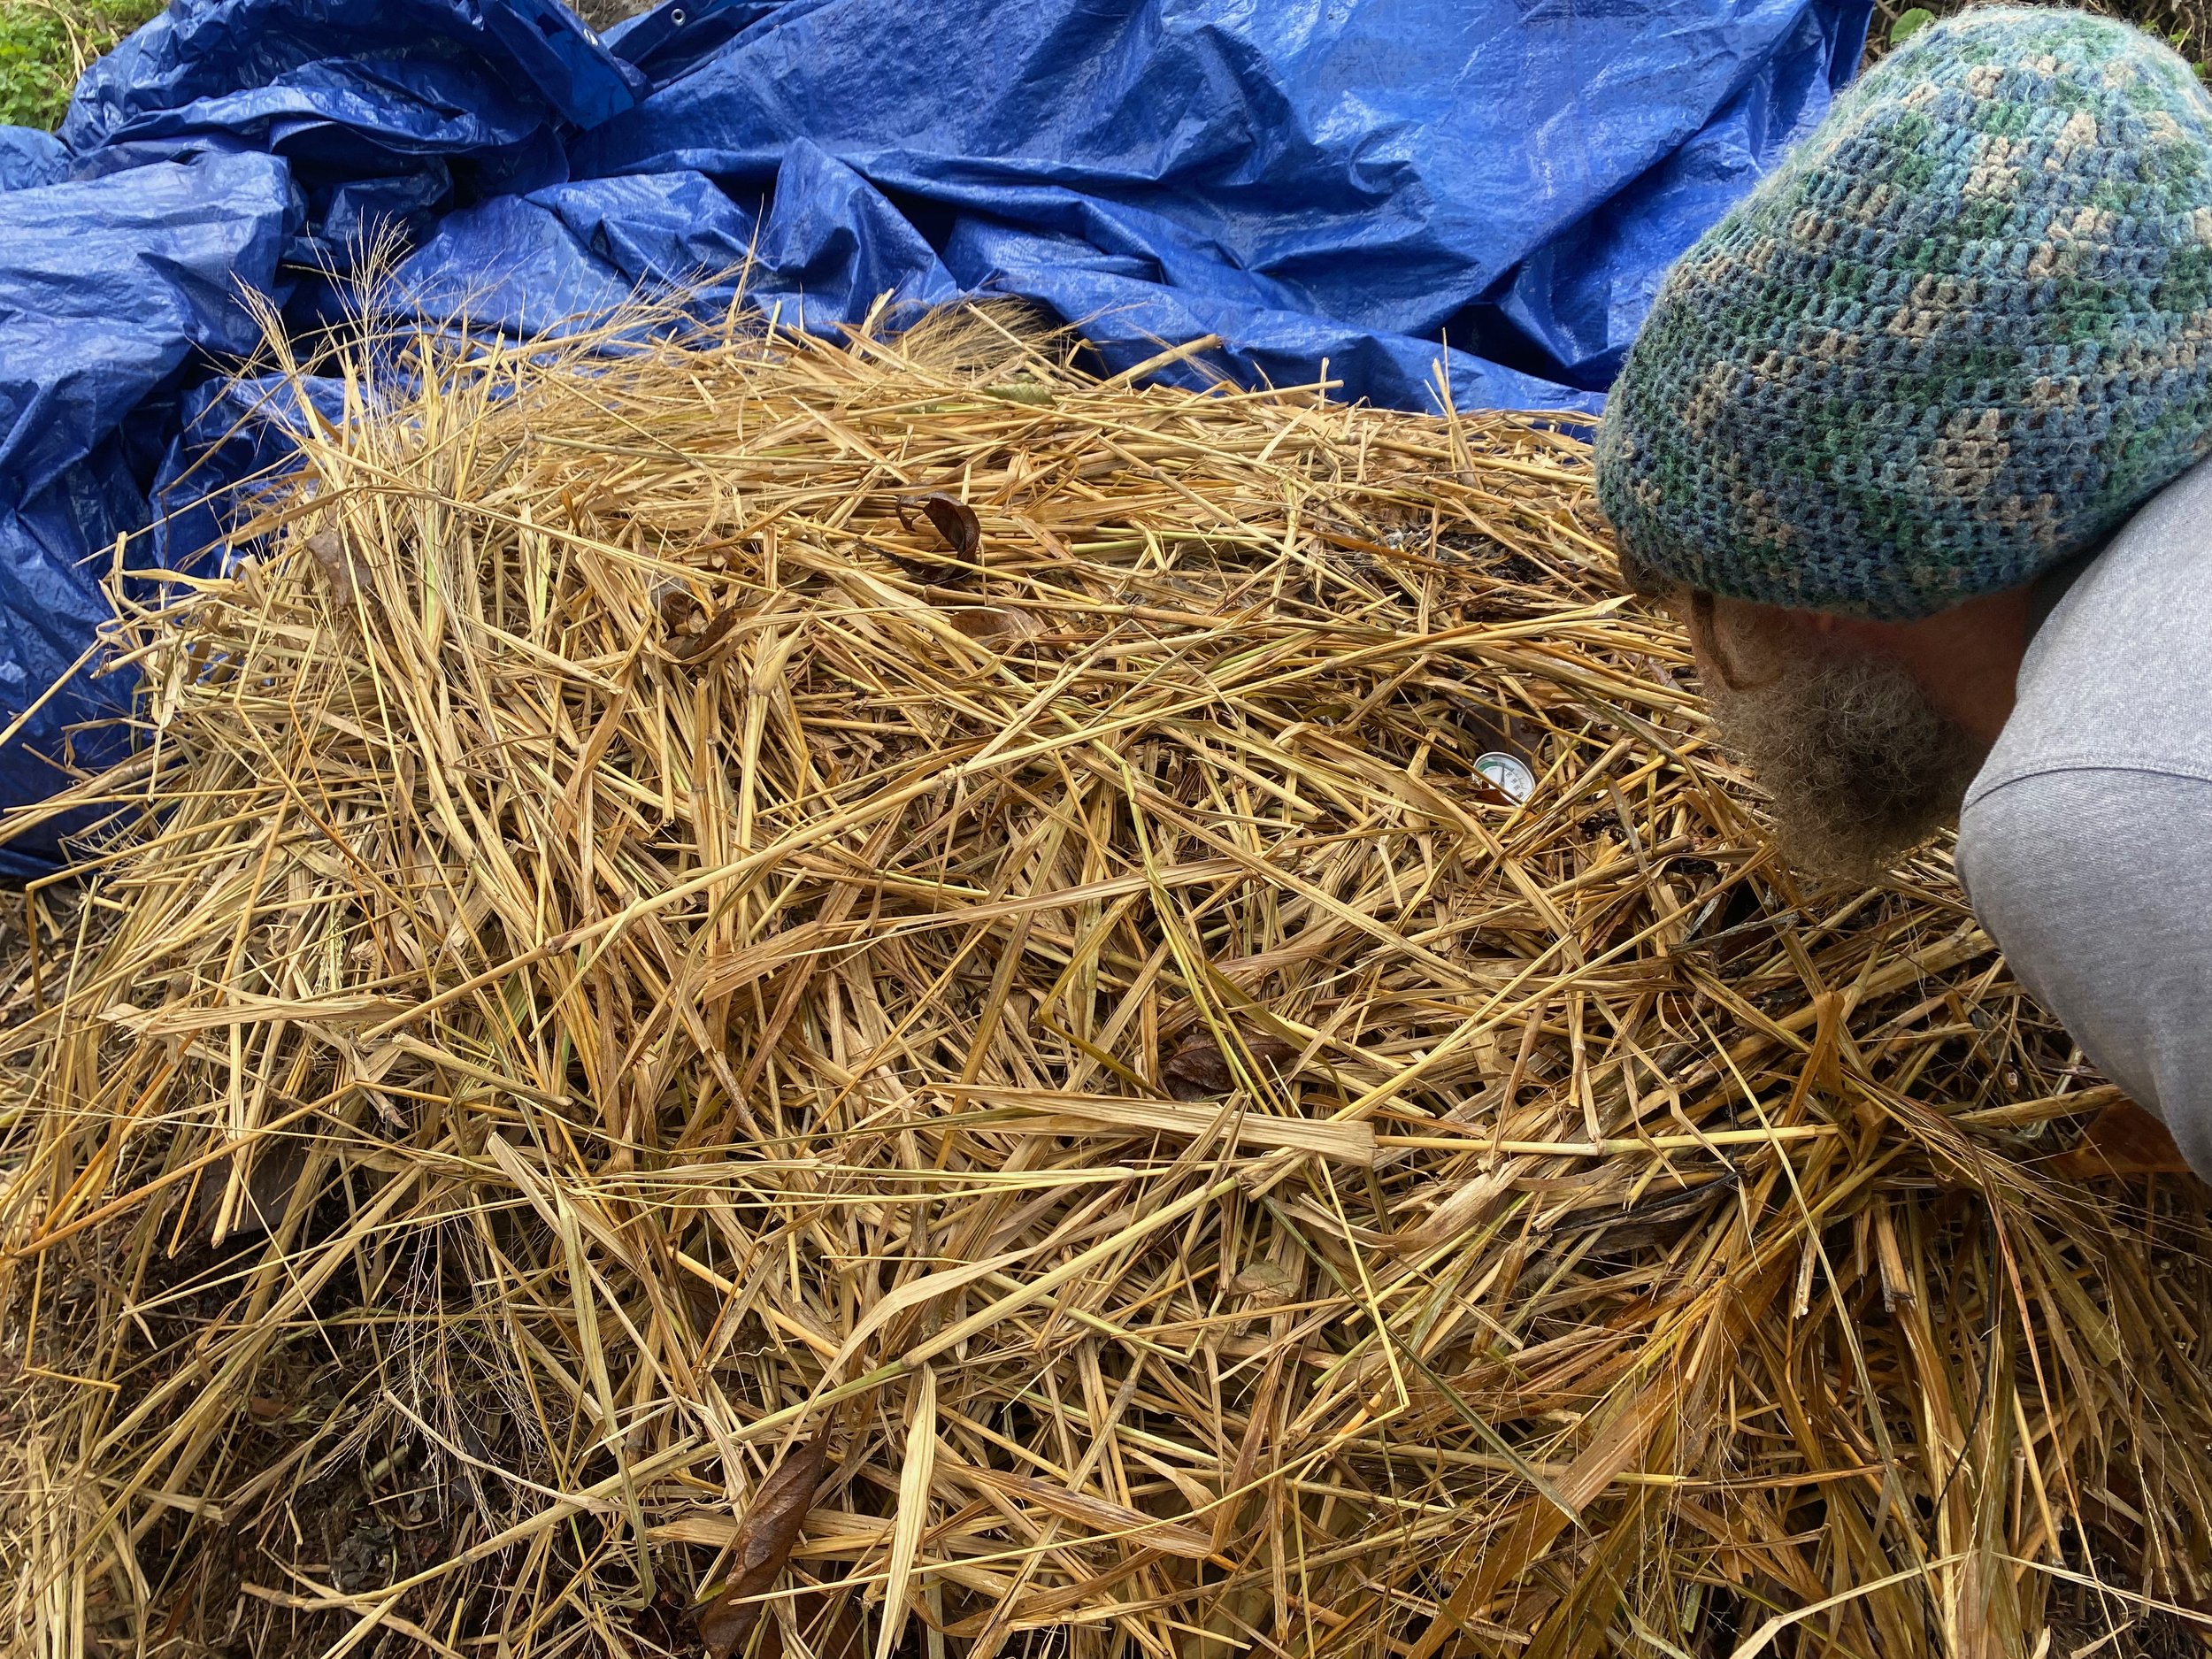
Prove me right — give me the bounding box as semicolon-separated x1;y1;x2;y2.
0;303;2212;1659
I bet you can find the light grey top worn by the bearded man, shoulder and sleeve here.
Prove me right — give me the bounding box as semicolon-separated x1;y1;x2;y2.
1958;463;2212;1179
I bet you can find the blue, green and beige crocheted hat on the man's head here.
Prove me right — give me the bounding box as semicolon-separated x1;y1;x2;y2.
1597;9;2212;619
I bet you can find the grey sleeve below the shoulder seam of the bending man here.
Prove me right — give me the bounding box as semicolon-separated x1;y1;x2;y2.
1958;768;2212;1179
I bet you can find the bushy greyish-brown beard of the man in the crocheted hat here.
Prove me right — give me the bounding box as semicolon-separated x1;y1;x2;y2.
1706;653;1989;880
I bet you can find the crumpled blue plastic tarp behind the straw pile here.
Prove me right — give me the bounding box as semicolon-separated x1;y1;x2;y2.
0;0;1871;874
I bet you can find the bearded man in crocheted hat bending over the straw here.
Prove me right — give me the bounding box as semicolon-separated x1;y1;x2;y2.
1597;9;2212;1179
